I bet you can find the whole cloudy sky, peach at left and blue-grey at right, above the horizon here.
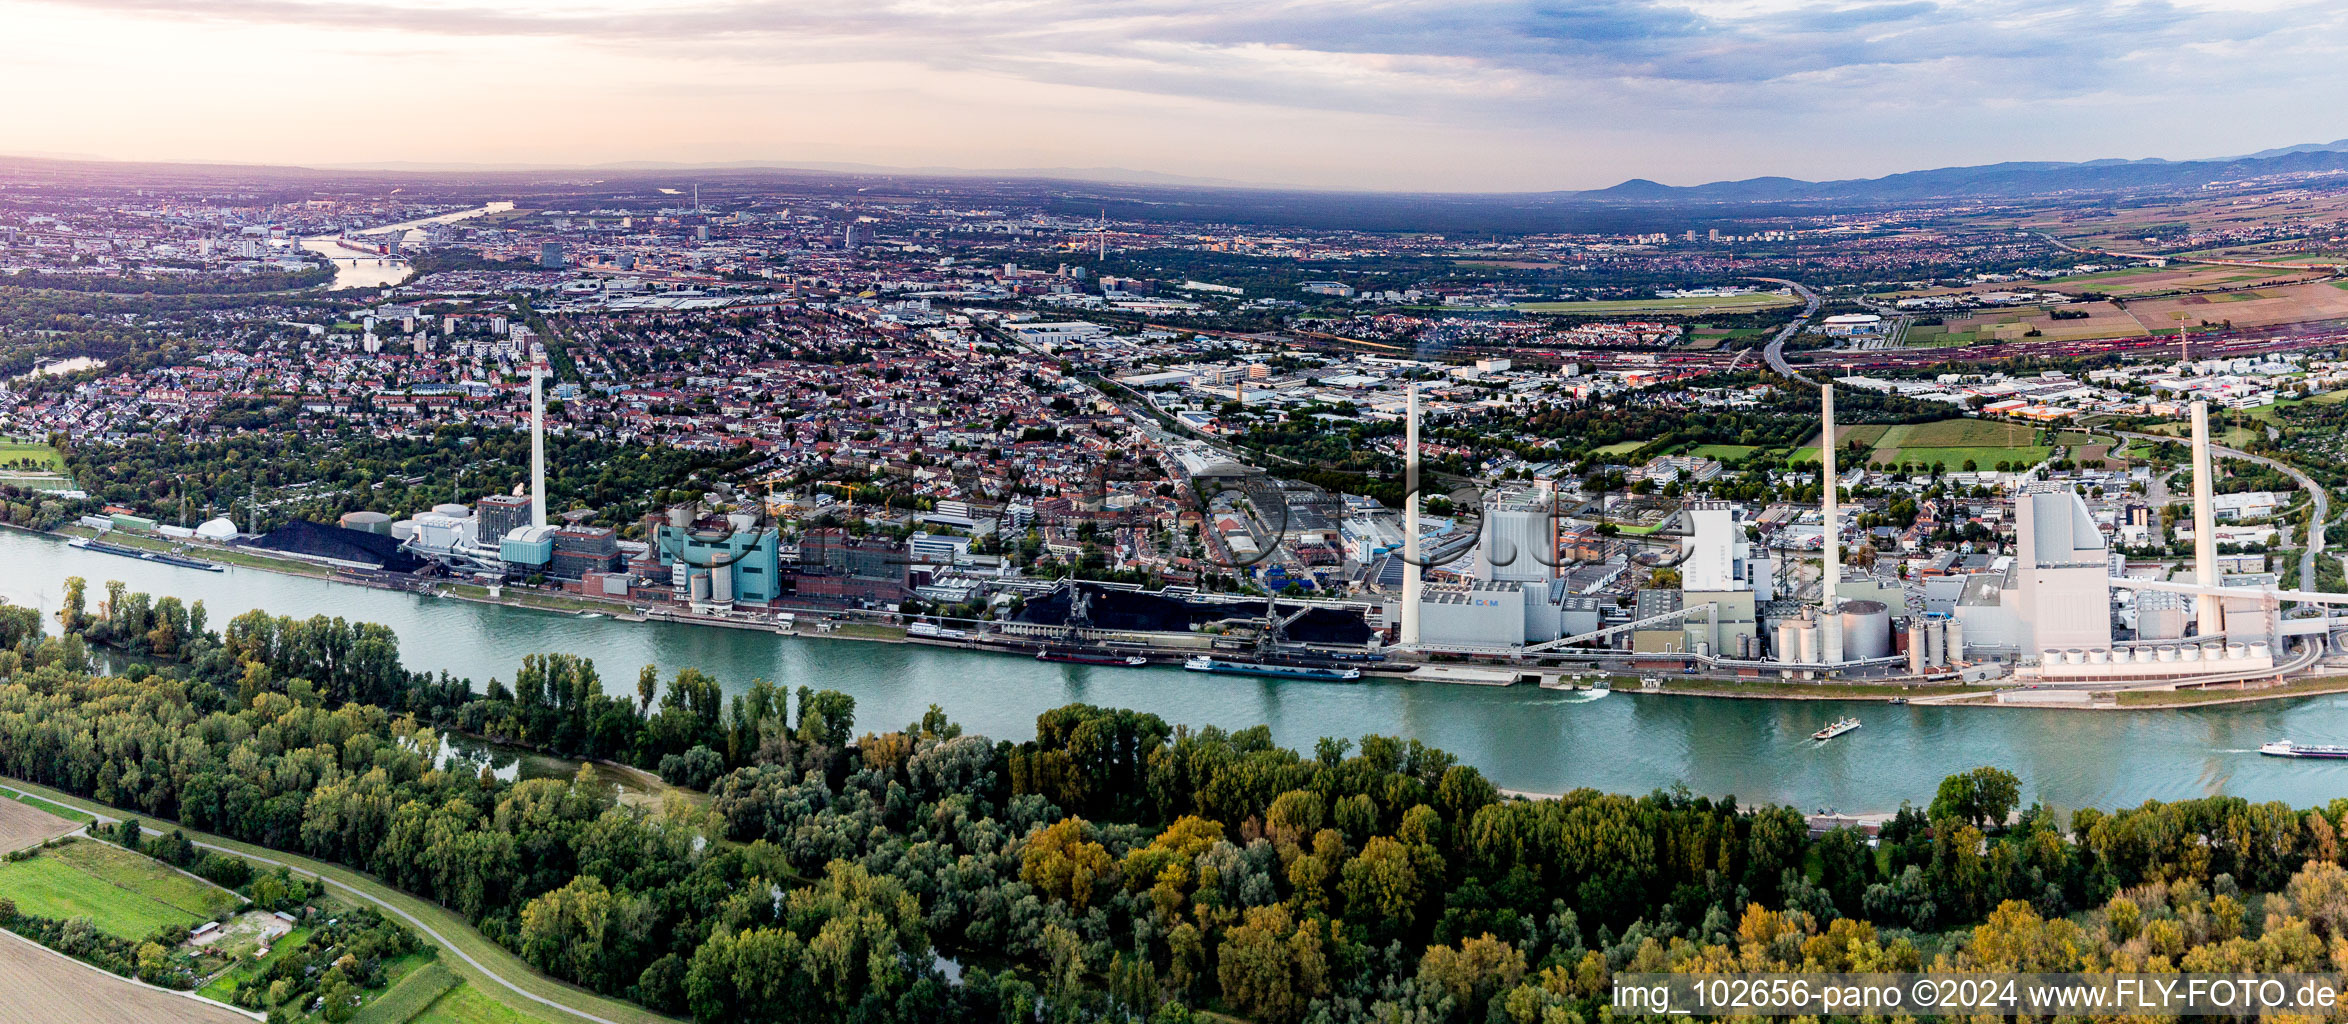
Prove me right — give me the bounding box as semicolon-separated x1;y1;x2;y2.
0;0;2348;190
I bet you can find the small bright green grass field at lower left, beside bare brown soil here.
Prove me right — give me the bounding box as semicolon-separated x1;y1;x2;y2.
0;838;237;939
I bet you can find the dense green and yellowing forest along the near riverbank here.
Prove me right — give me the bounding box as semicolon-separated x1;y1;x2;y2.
13;580;2348;1024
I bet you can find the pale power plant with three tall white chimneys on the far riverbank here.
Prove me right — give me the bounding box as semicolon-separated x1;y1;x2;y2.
1388;385;2348;686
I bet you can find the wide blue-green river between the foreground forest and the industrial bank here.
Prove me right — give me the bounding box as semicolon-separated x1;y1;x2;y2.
0;531;2348;813
